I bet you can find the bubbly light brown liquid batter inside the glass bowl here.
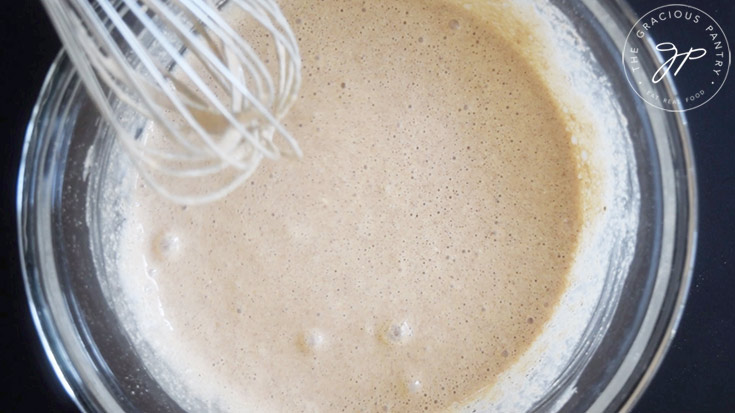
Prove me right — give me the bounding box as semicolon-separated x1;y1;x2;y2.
121;0;581;412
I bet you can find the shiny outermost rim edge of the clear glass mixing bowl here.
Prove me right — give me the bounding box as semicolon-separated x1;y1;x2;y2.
16;0;698;411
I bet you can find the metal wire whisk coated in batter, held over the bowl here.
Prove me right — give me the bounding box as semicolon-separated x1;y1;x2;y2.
43;0;301;204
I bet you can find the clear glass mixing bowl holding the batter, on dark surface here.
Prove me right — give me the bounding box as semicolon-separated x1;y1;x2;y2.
17;0;696;412
